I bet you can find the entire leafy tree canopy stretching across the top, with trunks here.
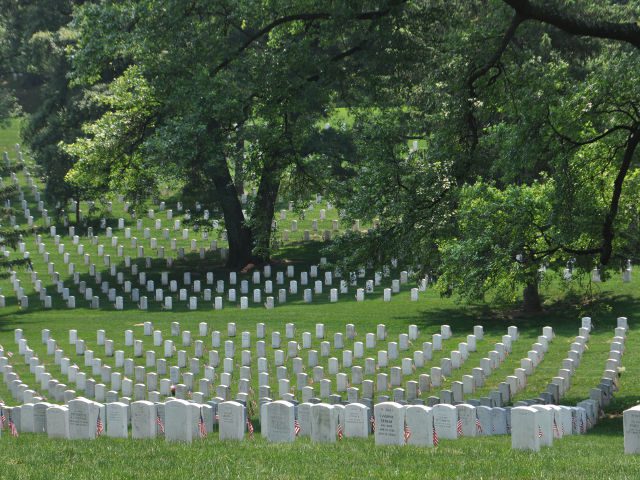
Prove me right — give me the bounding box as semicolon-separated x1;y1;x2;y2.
0;0;640;308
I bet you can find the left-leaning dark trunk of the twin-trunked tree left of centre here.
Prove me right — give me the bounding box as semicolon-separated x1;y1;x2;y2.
212;165;253;268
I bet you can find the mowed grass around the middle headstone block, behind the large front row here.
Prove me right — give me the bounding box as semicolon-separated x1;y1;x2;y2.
0;280;640;412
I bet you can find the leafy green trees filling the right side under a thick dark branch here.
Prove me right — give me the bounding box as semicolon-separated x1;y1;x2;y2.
328;1;640;309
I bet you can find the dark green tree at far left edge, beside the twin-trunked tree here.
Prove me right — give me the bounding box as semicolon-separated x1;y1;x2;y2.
0;0;106;218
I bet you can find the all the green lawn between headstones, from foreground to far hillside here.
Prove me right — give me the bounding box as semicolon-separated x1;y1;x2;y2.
0;117;640;480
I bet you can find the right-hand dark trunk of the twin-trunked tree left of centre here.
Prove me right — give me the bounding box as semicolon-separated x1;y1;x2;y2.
251;159;281;262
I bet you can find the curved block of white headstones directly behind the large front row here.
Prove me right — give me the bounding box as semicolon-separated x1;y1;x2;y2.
0;318;626;418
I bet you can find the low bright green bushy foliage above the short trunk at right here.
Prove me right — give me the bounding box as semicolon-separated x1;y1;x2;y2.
438;181;557;303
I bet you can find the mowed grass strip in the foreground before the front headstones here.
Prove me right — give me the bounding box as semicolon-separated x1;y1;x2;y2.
0;418;640;480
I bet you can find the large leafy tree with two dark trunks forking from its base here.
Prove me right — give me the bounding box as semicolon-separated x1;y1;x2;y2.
69;0;404;267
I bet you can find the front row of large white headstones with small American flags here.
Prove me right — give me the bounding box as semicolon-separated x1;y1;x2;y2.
2;397;599;451
